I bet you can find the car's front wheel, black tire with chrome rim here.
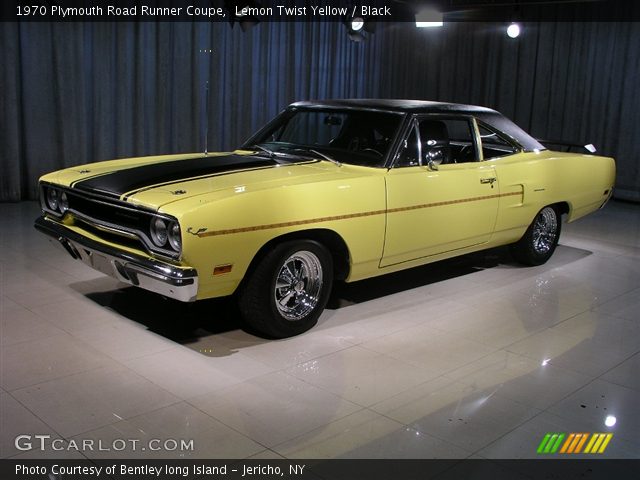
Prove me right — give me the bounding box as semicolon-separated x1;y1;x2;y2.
238;240;333;338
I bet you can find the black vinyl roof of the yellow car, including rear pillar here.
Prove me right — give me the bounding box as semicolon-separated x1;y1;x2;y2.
289;98;546;151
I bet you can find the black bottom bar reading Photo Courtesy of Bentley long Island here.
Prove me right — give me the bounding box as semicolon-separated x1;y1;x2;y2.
0;458;640;480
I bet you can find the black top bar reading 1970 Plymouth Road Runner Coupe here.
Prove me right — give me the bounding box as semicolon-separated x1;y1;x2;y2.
0;0;640;24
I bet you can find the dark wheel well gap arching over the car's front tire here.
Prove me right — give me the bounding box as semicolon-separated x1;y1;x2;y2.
245;228;350;280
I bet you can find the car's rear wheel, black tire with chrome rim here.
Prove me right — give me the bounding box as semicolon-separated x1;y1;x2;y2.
511;206;562;266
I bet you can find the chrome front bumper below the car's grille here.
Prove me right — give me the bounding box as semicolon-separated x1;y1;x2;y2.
34;216;198;302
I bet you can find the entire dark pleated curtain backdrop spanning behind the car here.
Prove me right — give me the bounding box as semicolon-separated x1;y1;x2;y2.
0;22;640;201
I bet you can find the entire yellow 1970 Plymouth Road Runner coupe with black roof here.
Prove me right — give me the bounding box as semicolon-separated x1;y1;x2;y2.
35;100;615;337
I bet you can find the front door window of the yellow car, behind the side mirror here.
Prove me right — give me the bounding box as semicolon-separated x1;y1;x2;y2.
418;115;478;165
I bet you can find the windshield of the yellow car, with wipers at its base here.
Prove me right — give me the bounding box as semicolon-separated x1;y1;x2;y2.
243;109;402;167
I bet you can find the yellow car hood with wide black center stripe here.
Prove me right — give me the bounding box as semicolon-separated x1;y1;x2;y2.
43;151;363;210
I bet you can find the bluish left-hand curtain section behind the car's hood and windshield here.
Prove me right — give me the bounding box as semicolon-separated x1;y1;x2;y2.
0;22;380;201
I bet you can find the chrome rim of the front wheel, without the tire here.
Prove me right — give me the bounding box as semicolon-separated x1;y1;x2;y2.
274;250;322;322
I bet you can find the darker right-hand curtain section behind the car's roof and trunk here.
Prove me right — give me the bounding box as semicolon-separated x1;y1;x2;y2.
379;22;640;201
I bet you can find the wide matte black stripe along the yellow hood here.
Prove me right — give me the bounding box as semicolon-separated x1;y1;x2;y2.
73;154;277;198
